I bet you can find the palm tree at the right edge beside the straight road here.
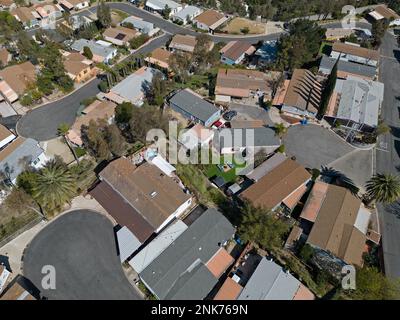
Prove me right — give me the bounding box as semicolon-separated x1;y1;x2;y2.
365;173;400;204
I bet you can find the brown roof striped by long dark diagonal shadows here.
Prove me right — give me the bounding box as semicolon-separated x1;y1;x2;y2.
283;69;321;112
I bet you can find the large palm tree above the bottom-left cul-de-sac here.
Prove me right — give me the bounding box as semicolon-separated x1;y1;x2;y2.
32;160;76;211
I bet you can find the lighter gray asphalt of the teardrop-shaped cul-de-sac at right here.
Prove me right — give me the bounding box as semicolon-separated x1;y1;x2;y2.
283;124;353;169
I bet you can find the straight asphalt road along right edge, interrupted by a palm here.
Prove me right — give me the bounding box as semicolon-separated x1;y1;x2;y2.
376;33;400;277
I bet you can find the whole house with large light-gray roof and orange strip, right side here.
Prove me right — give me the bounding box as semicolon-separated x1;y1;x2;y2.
325;76;384;131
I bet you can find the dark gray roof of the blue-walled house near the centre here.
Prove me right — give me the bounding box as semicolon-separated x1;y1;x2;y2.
169;89;219;122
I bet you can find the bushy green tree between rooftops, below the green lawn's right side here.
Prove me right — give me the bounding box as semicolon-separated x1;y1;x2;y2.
238;203;289;250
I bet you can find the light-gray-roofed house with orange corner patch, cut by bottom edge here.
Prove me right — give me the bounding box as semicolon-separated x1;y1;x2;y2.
238;258;315;300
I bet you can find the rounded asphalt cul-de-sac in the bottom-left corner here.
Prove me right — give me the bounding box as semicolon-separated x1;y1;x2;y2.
23;210;141;300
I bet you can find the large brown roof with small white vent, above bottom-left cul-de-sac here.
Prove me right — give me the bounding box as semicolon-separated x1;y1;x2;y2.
100;158;191;229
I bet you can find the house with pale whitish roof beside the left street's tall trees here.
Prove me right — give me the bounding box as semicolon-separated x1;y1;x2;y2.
105;67;160;107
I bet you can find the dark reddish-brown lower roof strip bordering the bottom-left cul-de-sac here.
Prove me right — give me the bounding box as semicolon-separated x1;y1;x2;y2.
89;181;154;243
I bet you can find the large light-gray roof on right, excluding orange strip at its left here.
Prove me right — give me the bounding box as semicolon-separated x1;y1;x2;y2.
336;76;384;127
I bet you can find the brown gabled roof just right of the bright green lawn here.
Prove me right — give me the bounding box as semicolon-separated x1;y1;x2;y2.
241;159;311;209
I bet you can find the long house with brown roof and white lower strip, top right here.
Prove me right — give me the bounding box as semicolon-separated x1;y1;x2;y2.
330;42;380;67
